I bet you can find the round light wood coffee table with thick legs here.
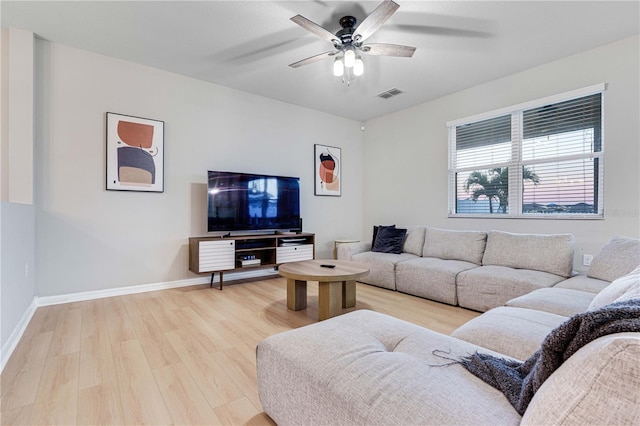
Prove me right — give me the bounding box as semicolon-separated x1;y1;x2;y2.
278;259;369;321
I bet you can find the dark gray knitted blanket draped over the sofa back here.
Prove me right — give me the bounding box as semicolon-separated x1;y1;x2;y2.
460;299;640;415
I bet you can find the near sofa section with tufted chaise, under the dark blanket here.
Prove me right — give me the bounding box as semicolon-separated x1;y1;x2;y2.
257;258;640;426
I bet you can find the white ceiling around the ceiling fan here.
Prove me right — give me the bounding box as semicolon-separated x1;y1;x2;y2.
0;0;640;121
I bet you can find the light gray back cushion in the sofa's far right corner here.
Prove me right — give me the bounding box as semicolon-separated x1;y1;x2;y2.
587;236;640;281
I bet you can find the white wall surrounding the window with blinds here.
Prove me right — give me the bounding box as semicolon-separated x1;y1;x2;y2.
362;36;640;269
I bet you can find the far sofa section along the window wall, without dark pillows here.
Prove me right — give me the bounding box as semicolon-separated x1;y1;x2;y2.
337;227;584;312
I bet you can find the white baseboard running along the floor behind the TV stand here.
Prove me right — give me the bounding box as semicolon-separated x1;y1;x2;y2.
35;269;278;306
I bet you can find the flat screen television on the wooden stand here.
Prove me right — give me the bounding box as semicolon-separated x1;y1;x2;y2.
207;171;300;232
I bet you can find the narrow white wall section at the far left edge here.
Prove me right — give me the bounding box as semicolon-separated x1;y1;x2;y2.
0;28;35;371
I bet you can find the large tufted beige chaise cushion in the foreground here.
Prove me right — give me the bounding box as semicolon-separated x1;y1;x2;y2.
257;310;520;425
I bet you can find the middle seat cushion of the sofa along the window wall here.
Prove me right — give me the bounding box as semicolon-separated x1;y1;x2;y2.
396;257;478;305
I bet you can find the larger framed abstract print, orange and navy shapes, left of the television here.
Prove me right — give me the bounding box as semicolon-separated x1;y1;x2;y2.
107;112;164;192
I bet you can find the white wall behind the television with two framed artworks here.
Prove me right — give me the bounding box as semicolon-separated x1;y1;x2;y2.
36;40;363;296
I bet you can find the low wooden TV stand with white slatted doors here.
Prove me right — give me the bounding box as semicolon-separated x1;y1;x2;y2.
189;232;315;290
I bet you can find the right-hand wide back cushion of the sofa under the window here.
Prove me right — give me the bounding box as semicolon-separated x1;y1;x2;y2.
482;231;574;277
